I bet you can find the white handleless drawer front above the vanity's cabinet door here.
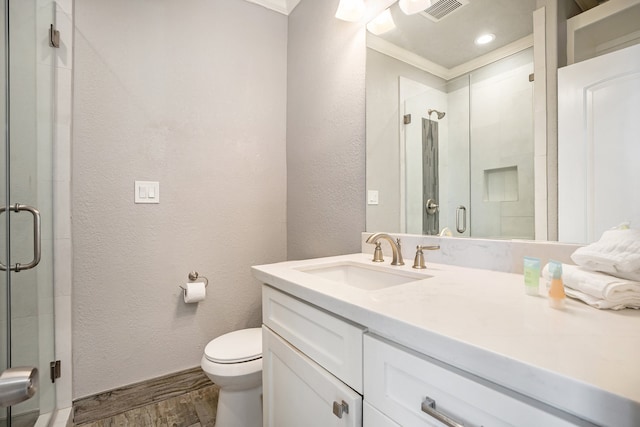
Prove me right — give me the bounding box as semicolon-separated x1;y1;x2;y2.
262;286;363;393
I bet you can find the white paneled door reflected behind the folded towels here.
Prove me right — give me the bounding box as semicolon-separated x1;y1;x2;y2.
558;45;640;243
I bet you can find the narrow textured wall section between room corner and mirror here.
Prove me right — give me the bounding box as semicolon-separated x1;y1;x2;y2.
287;0;366;259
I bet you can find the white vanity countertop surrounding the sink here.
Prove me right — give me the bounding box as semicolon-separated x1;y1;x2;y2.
253;254;640;426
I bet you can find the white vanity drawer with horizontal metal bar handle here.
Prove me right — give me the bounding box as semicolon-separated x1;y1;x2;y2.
364;335;589;427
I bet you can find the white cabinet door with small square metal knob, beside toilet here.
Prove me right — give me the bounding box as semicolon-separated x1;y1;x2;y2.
262;326;362;427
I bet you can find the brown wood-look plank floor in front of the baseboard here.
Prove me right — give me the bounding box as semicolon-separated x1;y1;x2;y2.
74;384;219;427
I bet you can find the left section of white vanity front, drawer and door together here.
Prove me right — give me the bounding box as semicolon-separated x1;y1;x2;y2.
262;286;363;427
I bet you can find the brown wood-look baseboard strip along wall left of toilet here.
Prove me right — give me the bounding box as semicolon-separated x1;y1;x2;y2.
73;367;212;424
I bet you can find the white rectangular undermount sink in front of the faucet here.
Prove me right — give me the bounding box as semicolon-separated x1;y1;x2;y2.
296;261;431;291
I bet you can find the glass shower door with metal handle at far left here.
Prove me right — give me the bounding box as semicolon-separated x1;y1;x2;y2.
0;0;55;426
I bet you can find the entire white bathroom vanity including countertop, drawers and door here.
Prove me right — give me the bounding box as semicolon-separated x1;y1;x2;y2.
253;254;640;427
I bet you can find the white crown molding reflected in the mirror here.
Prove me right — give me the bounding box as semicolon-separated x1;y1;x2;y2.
367;33;533;80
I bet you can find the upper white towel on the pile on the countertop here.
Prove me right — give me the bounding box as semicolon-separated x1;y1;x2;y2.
571;229;640;281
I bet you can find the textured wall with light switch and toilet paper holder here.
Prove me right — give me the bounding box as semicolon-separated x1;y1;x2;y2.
72;0;288;398
